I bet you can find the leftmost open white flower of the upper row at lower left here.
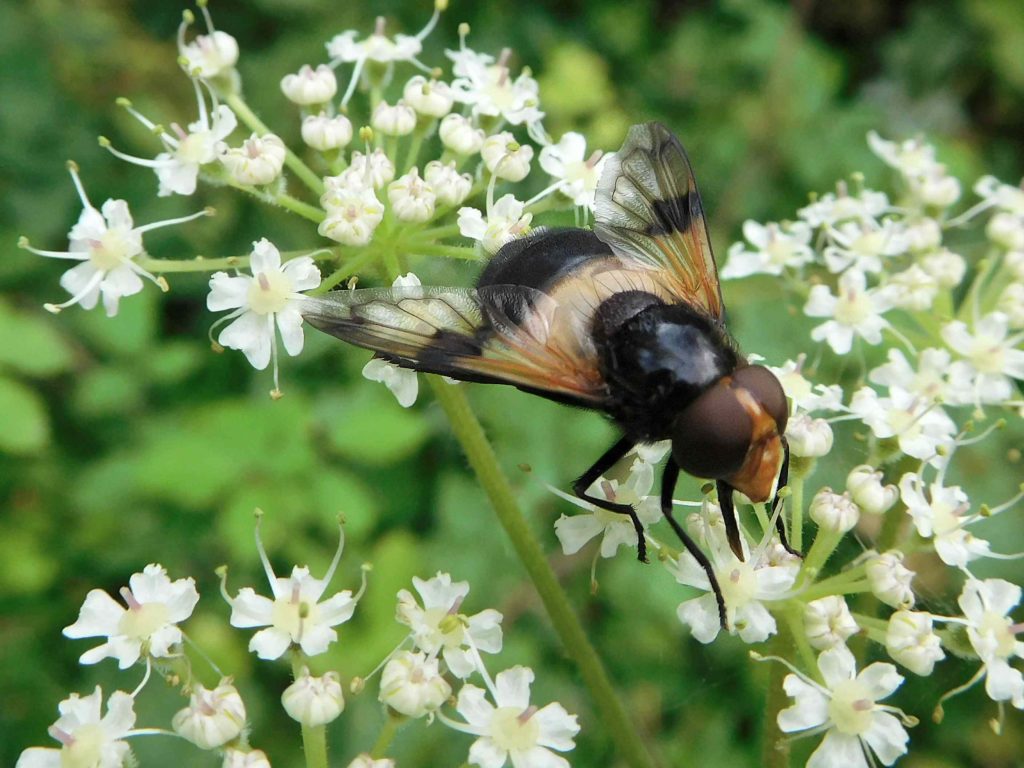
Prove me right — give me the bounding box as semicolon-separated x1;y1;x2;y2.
63;563;199;670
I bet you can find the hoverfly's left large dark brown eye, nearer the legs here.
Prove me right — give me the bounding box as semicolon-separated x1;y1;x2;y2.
672;382;754;478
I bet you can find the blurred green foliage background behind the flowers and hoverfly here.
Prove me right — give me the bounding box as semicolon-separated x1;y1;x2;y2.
0;0;1024;768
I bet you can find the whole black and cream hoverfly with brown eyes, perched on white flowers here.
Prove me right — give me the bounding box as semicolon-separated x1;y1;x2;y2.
303;123;792;629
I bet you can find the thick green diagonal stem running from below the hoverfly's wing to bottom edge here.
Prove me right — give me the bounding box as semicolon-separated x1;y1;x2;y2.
427;376;654;768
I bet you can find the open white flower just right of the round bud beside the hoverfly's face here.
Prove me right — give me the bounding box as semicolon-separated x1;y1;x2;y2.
850;386;956;461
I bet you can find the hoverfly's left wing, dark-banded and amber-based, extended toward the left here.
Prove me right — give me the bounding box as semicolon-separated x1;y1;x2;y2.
302;286;606;408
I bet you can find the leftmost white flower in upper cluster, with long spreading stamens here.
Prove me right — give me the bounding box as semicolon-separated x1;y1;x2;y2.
18;164;208;317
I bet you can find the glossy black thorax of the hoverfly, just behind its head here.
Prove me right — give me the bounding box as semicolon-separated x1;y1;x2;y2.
594;291;738;441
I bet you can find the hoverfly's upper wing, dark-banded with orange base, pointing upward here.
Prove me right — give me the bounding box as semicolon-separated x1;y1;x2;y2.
594;123;723;323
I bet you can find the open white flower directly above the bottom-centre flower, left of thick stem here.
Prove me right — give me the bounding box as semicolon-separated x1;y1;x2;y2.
396;572;502;679
